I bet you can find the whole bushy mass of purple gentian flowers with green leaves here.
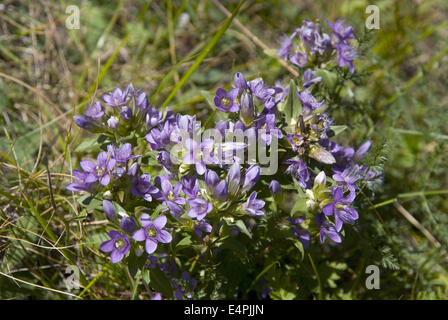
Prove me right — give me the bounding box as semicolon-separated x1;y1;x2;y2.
67;20;379;298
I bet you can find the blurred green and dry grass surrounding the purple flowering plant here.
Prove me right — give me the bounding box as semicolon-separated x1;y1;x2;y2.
0;0;448;299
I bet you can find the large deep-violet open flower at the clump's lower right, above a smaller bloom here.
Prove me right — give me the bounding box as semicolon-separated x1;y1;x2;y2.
322;187;359;232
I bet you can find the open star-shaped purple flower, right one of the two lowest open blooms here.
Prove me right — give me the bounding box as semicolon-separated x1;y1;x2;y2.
132;213;173;254
